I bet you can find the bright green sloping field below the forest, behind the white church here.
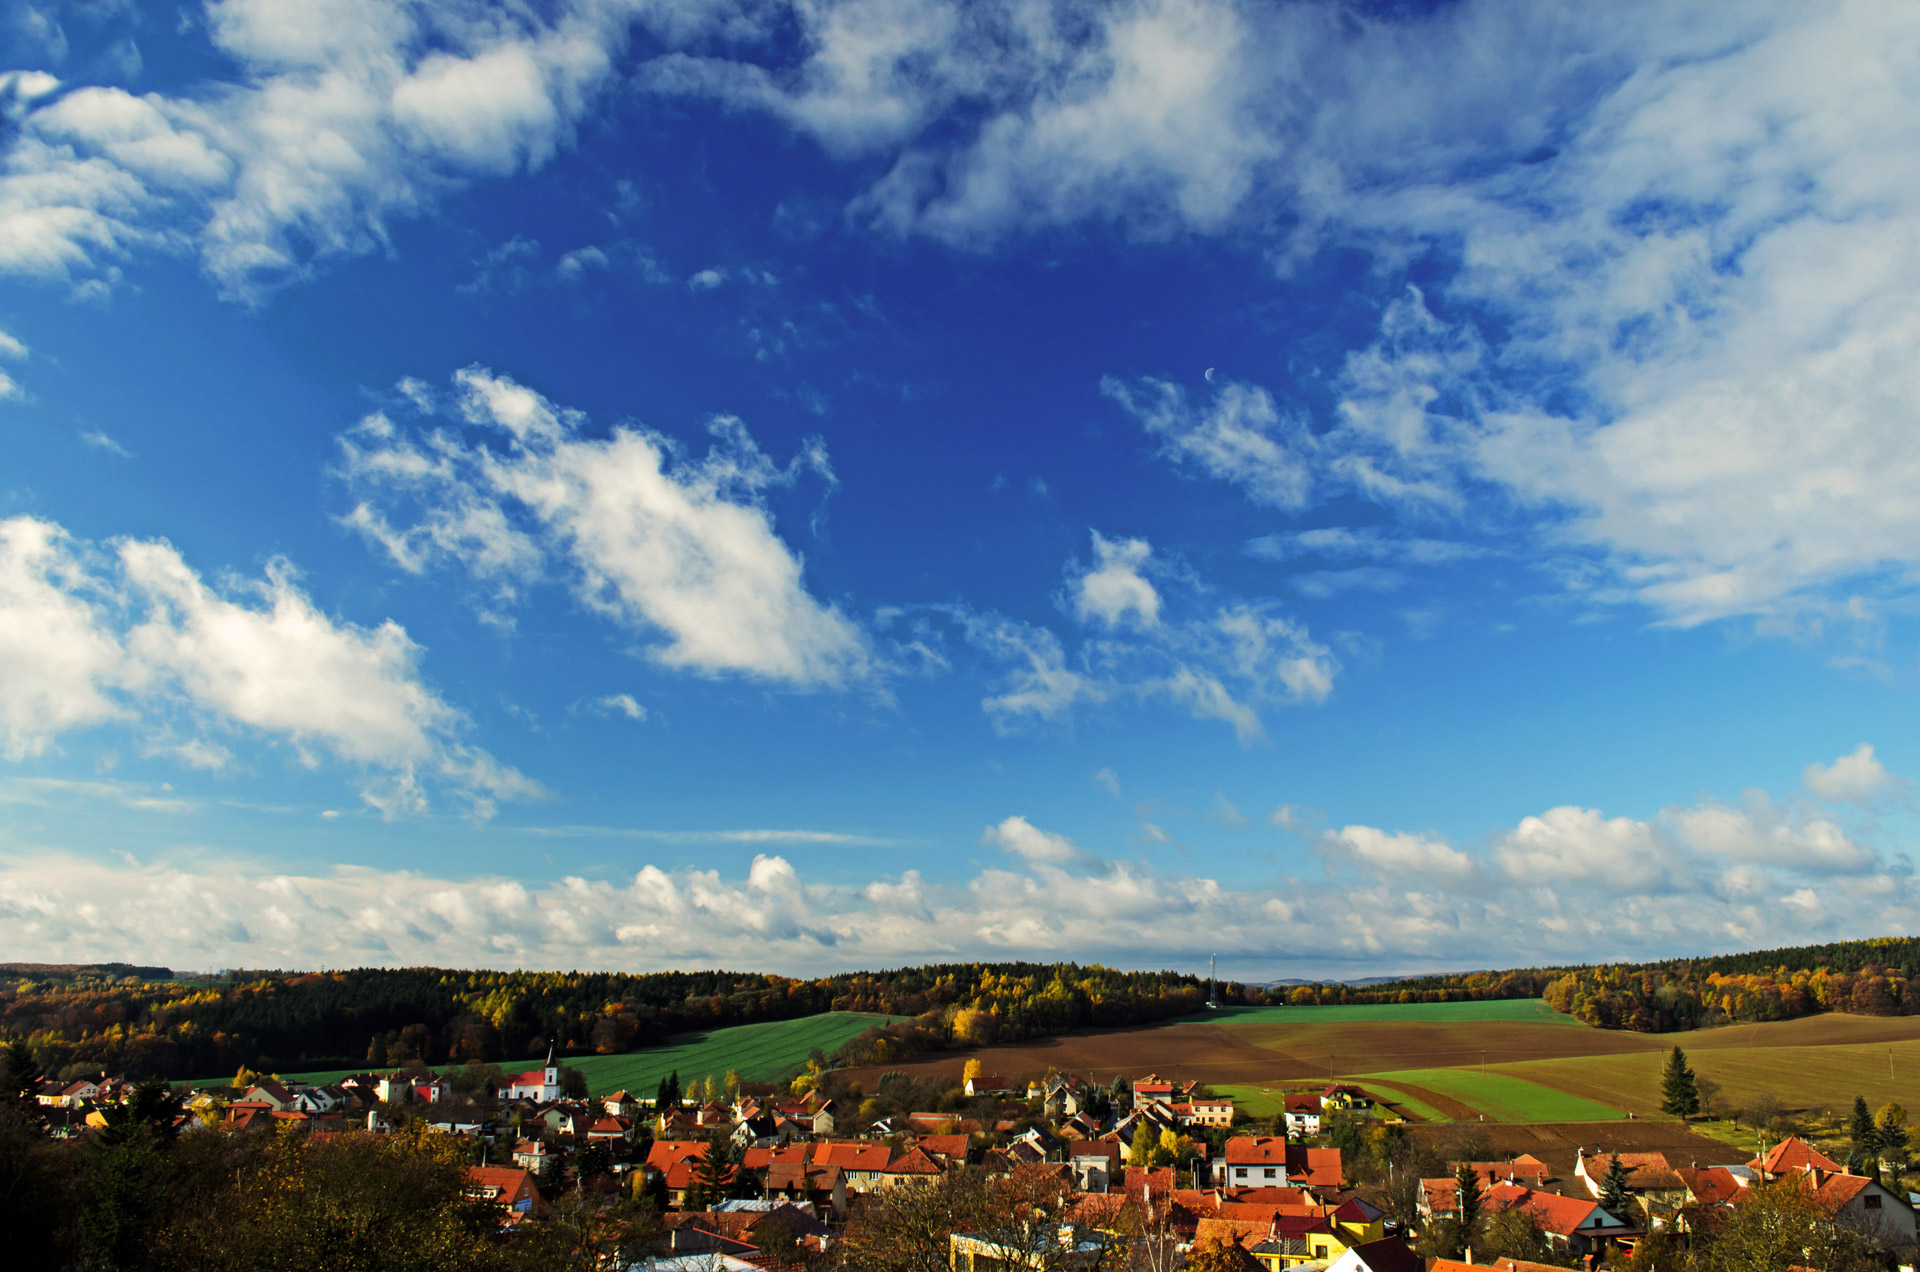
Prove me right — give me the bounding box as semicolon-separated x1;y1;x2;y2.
188;1011;906;1097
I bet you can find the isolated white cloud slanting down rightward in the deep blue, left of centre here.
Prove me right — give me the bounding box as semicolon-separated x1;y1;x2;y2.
340;367;877;688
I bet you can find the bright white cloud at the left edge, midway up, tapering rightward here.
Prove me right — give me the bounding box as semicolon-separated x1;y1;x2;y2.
0;517;541;815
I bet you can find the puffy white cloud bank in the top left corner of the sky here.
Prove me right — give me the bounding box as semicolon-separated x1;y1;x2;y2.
0;0;660;300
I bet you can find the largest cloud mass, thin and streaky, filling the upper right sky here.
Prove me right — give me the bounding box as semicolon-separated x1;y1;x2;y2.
641;0;1920;624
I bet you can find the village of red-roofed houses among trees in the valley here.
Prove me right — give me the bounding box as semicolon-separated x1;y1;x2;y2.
36;1053;1916;1272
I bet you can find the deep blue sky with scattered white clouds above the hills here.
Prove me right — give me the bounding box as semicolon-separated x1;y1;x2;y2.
0;0;1920;980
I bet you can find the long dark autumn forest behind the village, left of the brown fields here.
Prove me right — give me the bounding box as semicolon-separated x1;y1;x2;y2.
0;963;1206;1078
